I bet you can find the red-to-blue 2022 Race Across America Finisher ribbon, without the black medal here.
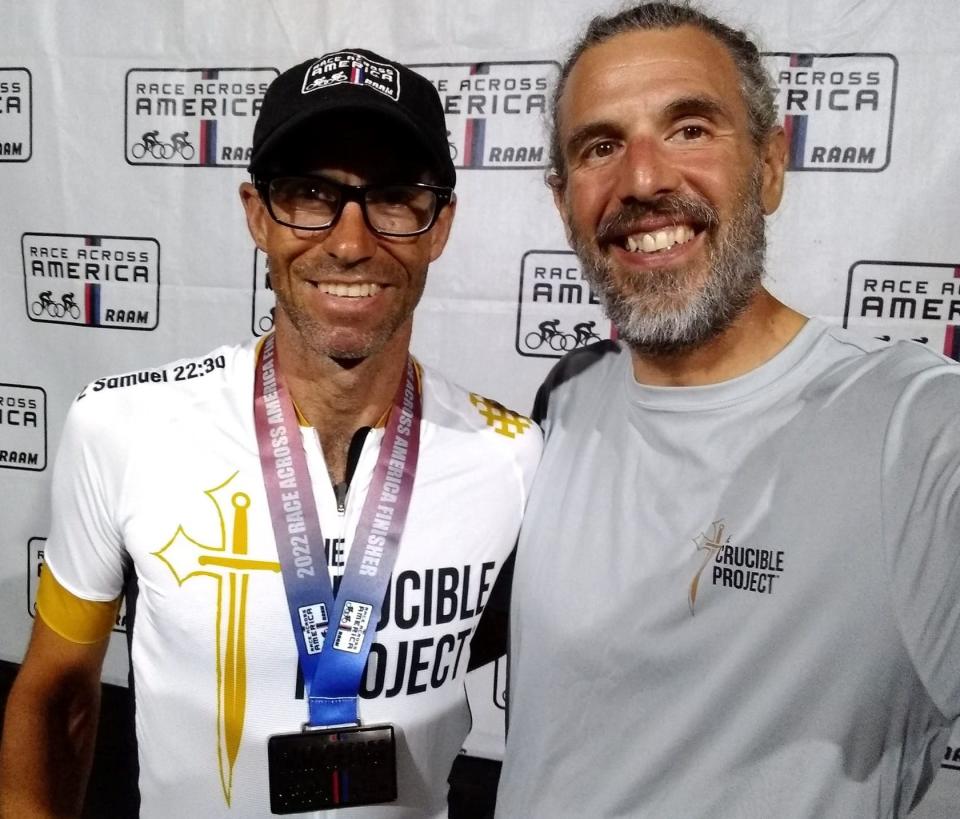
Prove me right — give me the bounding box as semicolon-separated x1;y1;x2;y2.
253;334;421;726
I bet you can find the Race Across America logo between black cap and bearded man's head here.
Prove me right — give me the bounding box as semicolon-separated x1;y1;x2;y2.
410;62;560;170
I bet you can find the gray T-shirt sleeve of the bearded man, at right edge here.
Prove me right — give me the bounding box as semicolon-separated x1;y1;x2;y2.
882;365;960;719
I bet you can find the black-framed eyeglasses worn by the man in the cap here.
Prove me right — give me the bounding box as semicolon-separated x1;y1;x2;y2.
256;176;453;236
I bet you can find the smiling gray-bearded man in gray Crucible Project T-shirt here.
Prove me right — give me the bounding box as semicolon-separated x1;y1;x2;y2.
497;3;960;819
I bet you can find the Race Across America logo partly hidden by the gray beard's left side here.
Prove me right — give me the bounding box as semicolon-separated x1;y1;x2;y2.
516;250;614;358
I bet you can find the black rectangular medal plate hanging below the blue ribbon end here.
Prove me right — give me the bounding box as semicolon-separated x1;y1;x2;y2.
267;725;397;814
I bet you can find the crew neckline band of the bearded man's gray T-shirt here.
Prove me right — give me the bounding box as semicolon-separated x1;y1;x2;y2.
623;317;829;412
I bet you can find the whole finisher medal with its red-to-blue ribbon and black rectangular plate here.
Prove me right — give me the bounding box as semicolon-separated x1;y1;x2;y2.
254;335;421;814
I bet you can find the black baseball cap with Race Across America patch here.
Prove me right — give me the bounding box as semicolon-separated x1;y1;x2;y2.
248;48;457;188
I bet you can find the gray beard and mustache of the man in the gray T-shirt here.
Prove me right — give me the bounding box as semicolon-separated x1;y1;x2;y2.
567;164;766;355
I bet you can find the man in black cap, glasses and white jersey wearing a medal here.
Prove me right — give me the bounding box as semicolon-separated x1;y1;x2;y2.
0;50;540;817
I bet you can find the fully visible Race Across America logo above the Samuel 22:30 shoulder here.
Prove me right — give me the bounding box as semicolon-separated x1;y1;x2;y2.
22;233;160;330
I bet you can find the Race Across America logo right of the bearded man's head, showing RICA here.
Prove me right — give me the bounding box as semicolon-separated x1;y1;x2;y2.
765;52;897;171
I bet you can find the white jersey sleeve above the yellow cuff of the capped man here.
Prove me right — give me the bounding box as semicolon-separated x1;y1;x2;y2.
44;396;131;602
